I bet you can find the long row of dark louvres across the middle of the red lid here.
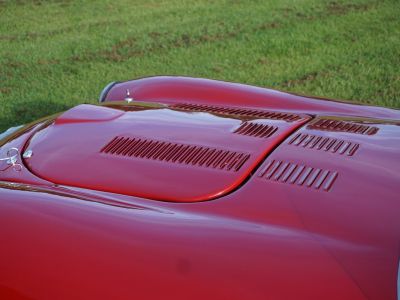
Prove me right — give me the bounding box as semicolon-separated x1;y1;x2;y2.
100;137;250;172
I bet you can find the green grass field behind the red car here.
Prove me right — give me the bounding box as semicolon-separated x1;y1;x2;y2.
0;0;400;130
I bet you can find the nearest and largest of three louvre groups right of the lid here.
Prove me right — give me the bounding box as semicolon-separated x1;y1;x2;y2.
258;160;338;191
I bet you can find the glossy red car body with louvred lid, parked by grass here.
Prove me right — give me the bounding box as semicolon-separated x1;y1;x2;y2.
0;77;400;300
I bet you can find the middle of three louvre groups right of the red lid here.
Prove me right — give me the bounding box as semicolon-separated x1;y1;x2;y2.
289;133;360;156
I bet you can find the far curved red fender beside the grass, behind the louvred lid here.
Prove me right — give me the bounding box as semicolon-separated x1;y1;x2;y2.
103;76;400;120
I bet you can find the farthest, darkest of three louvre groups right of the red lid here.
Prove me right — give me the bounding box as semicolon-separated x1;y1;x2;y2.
307;119;379;135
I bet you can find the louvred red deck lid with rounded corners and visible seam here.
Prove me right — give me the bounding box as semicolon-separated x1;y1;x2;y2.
25;103;309;202
